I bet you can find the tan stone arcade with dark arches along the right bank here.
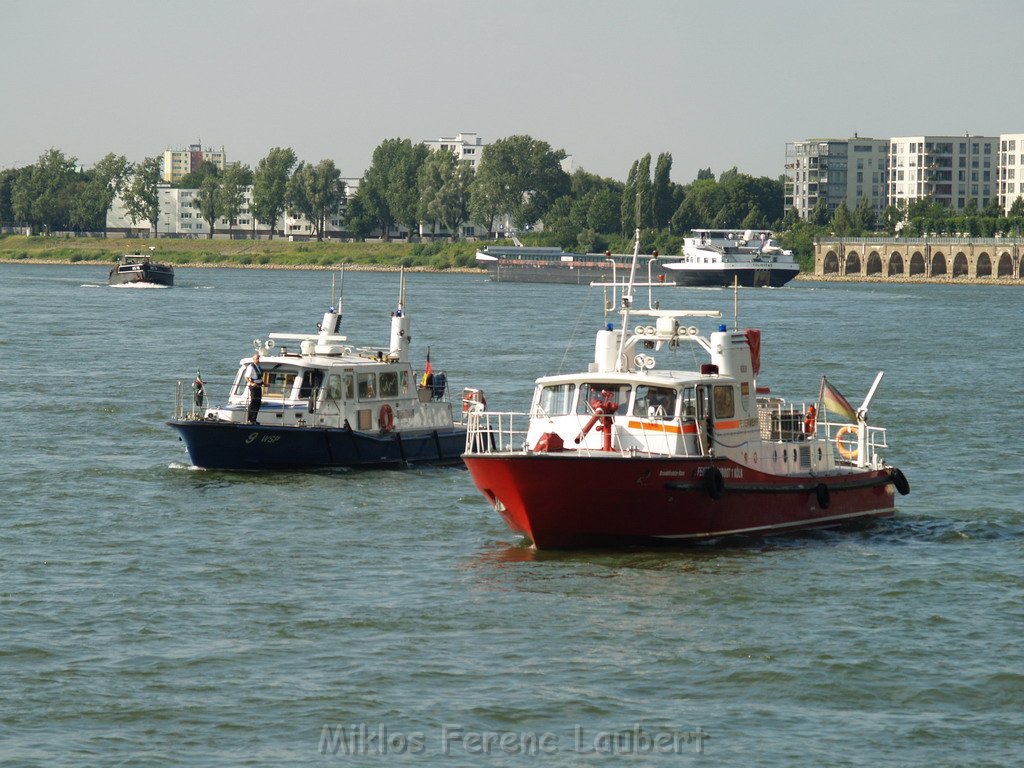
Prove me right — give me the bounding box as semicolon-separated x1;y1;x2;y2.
814;238;1024;283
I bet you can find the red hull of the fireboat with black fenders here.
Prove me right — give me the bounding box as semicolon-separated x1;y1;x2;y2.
464;454;895;549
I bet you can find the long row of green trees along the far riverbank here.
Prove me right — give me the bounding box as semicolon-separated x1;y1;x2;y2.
0;135;782;250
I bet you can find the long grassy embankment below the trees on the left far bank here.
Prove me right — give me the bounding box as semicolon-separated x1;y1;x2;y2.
0;236;489;270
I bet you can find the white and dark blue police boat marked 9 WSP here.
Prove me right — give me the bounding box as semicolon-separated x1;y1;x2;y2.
167;273;484;470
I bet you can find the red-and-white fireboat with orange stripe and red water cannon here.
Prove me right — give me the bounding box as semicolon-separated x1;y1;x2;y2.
463;231;909;549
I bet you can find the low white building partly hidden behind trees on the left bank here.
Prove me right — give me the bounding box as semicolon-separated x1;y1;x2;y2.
106;186;345;240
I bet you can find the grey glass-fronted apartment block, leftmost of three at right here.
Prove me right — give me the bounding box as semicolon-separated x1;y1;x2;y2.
785;134;889;218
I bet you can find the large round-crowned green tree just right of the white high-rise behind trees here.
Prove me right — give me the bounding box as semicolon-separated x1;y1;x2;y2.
472;135;571;228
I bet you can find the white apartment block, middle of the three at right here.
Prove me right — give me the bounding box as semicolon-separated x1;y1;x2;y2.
889;134;999;211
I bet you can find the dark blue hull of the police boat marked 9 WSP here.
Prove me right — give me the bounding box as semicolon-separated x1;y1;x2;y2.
167;419;466;470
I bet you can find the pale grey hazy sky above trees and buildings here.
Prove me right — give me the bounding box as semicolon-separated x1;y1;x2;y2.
0;0;1024;182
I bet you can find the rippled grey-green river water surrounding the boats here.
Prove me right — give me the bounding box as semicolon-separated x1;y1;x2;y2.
0;264;1024;766
